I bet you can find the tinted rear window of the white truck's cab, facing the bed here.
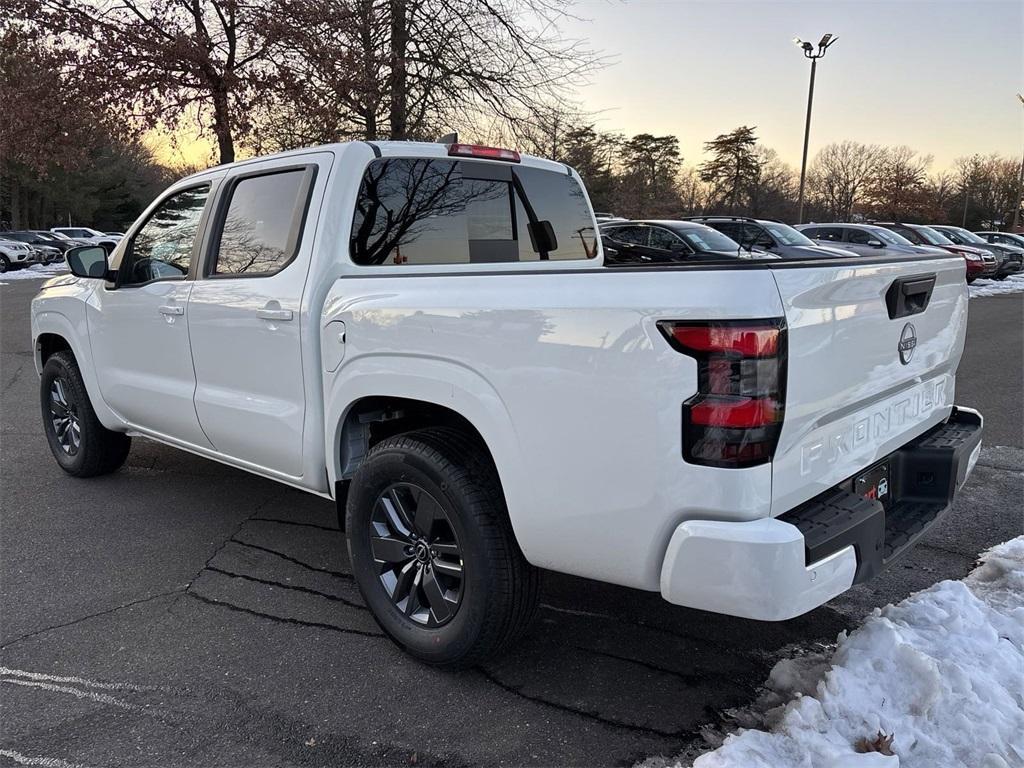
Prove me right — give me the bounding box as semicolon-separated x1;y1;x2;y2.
350;158;597;266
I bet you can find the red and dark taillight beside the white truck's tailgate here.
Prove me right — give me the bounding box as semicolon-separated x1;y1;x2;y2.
658;319;785;467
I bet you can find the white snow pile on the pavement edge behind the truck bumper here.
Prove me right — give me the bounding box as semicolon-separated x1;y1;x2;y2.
693;537;1024;768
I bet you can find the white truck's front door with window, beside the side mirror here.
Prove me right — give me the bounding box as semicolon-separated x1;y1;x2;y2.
86;181;212;447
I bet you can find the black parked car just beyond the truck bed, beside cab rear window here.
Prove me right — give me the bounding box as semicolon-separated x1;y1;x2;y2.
600;219;765;264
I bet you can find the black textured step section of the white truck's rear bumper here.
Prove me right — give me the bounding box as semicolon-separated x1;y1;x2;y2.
777;409;982;584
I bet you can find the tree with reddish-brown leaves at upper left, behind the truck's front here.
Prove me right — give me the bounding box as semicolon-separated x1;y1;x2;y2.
24;0;280;163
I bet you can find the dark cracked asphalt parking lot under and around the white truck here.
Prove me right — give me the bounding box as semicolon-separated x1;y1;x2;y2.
0;281;1024;768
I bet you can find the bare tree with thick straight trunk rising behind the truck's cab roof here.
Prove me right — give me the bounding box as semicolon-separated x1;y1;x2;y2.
261;0;600;151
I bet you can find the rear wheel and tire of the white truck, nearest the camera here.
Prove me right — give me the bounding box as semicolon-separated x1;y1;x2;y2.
345;428;540;668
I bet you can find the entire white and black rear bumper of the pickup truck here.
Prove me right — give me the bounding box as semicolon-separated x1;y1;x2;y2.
662;409;983;621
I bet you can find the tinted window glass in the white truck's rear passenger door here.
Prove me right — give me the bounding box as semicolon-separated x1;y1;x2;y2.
212;168;311;275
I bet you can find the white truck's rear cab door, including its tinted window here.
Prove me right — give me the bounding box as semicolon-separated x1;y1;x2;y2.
182;153;333;477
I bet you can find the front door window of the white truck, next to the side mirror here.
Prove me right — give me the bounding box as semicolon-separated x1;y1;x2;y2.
117;184;210;286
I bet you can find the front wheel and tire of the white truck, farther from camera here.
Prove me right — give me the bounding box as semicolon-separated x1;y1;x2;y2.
39;350;131;477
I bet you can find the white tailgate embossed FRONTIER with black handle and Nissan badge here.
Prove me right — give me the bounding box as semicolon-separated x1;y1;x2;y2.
771;257;968;516
